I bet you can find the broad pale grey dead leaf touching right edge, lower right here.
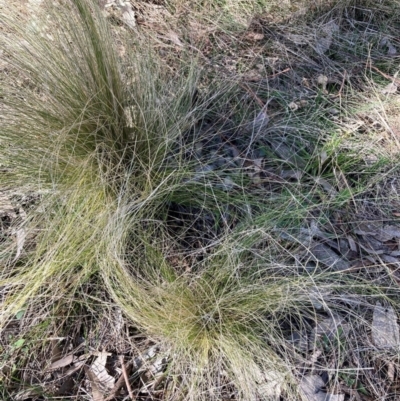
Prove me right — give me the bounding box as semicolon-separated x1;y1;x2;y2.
372;302;400;348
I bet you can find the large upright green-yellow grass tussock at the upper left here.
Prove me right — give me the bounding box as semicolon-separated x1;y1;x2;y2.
0;0;200;325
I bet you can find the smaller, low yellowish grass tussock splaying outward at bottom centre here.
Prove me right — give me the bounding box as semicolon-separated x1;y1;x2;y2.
103;217;312;400
